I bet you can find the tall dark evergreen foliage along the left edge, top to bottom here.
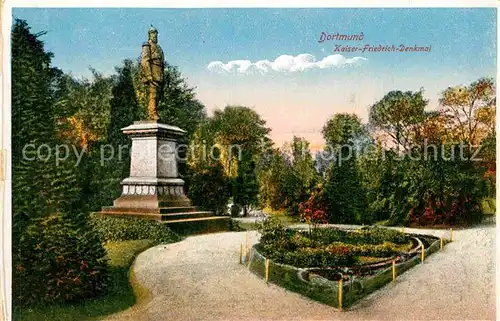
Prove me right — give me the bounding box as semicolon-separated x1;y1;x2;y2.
12;20;107;306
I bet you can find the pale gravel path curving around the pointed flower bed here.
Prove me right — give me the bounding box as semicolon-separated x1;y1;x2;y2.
103;221;495;321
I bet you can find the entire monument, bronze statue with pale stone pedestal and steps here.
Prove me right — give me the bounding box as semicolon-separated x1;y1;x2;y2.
100;27;222;228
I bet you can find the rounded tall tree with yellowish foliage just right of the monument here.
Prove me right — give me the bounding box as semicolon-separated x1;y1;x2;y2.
188;106;270;211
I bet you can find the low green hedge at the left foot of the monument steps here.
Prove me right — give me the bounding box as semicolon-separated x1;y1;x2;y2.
90;213;179;243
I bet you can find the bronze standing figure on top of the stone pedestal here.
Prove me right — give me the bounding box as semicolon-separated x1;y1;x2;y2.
141;26;165;121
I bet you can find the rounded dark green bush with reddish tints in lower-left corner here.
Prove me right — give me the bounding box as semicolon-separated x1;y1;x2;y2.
12;214;108;306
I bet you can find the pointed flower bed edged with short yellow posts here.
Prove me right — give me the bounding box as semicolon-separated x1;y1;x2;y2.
252;222;440;307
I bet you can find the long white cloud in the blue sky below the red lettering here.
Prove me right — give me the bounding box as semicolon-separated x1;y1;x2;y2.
207;54;367;74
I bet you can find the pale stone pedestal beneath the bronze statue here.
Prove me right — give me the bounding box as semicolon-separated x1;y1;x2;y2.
107;121;191;213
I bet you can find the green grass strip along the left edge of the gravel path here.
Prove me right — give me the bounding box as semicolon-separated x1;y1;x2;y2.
14;240;156;321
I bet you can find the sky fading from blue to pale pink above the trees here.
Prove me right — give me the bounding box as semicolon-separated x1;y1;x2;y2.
13;8;497;149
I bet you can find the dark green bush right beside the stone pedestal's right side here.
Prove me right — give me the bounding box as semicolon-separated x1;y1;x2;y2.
187;162;230;215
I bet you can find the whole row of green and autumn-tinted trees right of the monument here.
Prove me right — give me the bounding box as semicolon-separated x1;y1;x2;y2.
190;84;496;225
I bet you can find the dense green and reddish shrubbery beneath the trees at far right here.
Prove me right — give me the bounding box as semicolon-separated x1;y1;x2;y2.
379;145;487;225
